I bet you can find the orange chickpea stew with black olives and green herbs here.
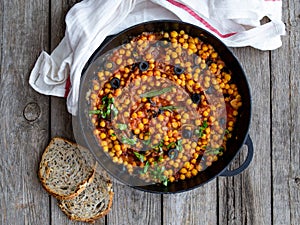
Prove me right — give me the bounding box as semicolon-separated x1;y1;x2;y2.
87;30;243;186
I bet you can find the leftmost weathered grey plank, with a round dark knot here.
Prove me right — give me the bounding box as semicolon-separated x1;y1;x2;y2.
0;0;50;225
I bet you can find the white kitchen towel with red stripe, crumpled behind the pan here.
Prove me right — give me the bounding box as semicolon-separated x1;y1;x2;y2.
29;0;285;115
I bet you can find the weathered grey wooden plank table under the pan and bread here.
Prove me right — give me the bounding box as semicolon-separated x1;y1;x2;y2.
0;0;300;225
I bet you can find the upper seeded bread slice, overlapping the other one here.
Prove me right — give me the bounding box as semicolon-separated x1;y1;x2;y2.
38;137;96;200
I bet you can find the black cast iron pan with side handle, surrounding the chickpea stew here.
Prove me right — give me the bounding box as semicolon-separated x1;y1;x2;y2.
75;21;253;193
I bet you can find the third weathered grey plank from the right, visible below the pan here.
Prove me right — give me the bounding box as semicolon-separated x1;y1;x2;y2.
163;180;218;225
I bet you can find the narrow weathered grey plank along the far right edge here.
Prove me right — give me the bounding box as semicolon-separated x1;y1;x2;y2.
271;1;300;225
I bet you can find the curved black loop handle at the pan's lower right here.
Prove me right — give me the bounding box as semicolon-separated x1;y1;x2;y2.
220;135;253;177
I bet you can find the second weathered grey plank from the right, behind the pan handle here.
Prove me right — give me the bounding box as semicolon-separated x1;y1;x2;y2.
219;48;271;224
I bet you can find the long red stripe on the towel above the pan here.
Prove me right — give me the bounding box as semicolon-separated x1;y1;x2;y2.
167;0;236;38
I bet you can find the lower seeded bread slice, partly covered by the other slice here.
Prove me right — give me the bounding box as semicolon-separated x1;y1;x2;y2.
58;171;114;223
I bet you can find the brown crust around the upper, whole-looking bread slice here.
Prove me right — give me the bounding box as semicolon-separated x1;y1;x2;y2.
38;137;96;200
